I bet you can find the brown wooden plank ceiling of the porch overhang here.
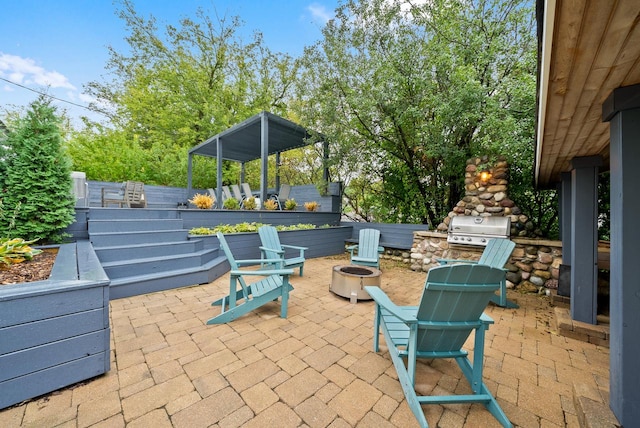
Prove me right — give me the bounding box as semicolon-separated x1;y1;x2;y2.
535;0;640;188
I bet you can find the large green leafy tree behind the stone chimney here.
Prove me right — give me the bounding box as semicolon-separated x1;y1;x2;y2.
295;0;536;227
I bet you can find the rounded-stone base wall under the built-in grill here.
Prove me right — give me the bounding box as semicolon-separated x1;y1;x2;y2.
410;231;562;292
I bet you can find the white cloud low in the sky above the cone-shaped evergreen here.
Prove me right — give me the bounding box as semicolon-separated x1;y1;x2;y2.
0;52;76;90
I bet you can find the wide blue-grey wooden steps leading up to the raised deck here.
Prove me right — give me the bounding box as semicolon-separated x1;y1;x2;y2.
87;210;229;299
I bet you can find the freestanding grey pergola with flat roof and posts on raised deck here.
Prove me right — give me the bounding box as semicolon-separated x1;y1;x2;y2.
187;111;329;208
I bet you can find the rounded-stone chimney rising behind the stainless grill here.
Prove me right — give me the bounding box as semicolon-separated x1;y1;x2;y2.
437;156;539;237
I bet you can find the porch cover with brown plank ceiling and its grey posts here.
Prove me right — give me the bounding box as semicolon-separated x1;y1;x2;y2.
535;0;640;426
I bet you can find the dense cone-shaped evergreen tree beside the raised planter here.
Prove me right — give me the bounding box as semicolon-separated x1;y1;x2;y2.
0;96;75;241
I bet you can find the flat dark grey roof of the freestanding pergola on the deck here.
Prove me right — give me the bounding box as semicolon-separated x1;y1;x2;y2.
189;111;311;162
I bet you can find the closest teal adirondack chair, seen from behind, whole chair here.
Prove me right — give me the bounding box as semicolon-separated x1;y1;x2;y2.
365;264;512;427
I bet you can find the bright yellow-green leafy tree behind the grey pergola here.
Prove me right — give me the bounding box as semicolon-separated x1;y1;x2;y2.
73;0;297;187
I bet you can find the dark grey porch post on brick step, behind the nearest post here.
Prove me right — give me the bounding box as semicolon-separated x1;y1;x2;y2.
563;156;602;324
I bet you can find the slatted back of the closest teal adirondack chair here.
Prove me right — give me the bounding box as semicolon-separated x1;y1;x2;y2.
416;264;505;352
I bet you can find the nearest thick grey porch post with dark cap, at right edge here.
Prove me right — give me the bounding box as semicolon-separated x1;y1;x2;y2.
602;85;640;426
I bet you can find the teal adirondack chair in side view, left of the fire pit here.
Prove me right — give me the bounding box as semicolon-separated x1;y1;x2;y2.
207;232;293;324
